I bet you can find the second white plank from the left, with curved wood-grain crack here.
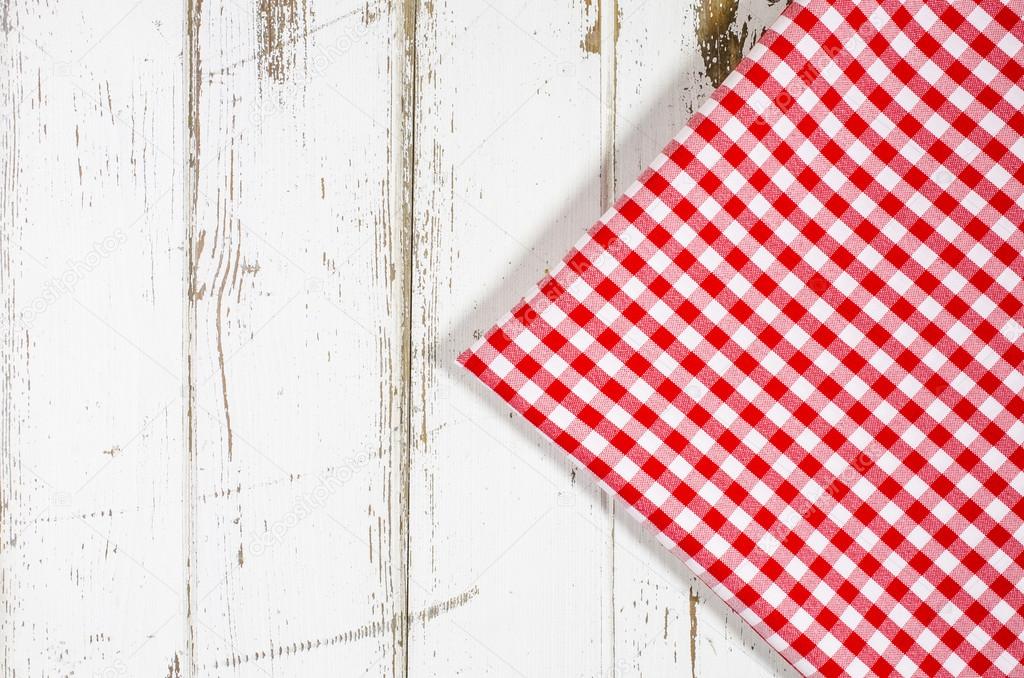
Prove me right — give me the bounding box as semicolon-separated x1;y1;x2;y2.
185;0;408;677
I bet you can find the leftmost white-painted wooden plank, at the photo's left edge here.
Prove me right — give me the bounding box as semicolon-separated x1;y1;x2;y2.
0;0;184;678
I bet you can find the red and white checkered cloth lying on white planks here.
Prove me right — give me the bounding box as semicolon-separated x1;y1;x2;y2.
460;0;1024;676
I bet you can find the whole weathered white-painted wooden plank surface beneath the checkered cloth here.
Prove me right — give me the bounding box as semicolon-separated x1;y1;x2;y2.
0;0;794;678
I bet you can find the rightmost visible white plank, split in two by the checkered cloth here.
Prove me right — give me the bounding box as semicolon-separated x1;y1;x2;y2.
614;0;797;678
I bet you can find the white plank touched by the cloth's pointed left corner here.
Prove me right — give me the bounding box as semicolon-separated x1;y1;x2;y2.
410;0;613;677
